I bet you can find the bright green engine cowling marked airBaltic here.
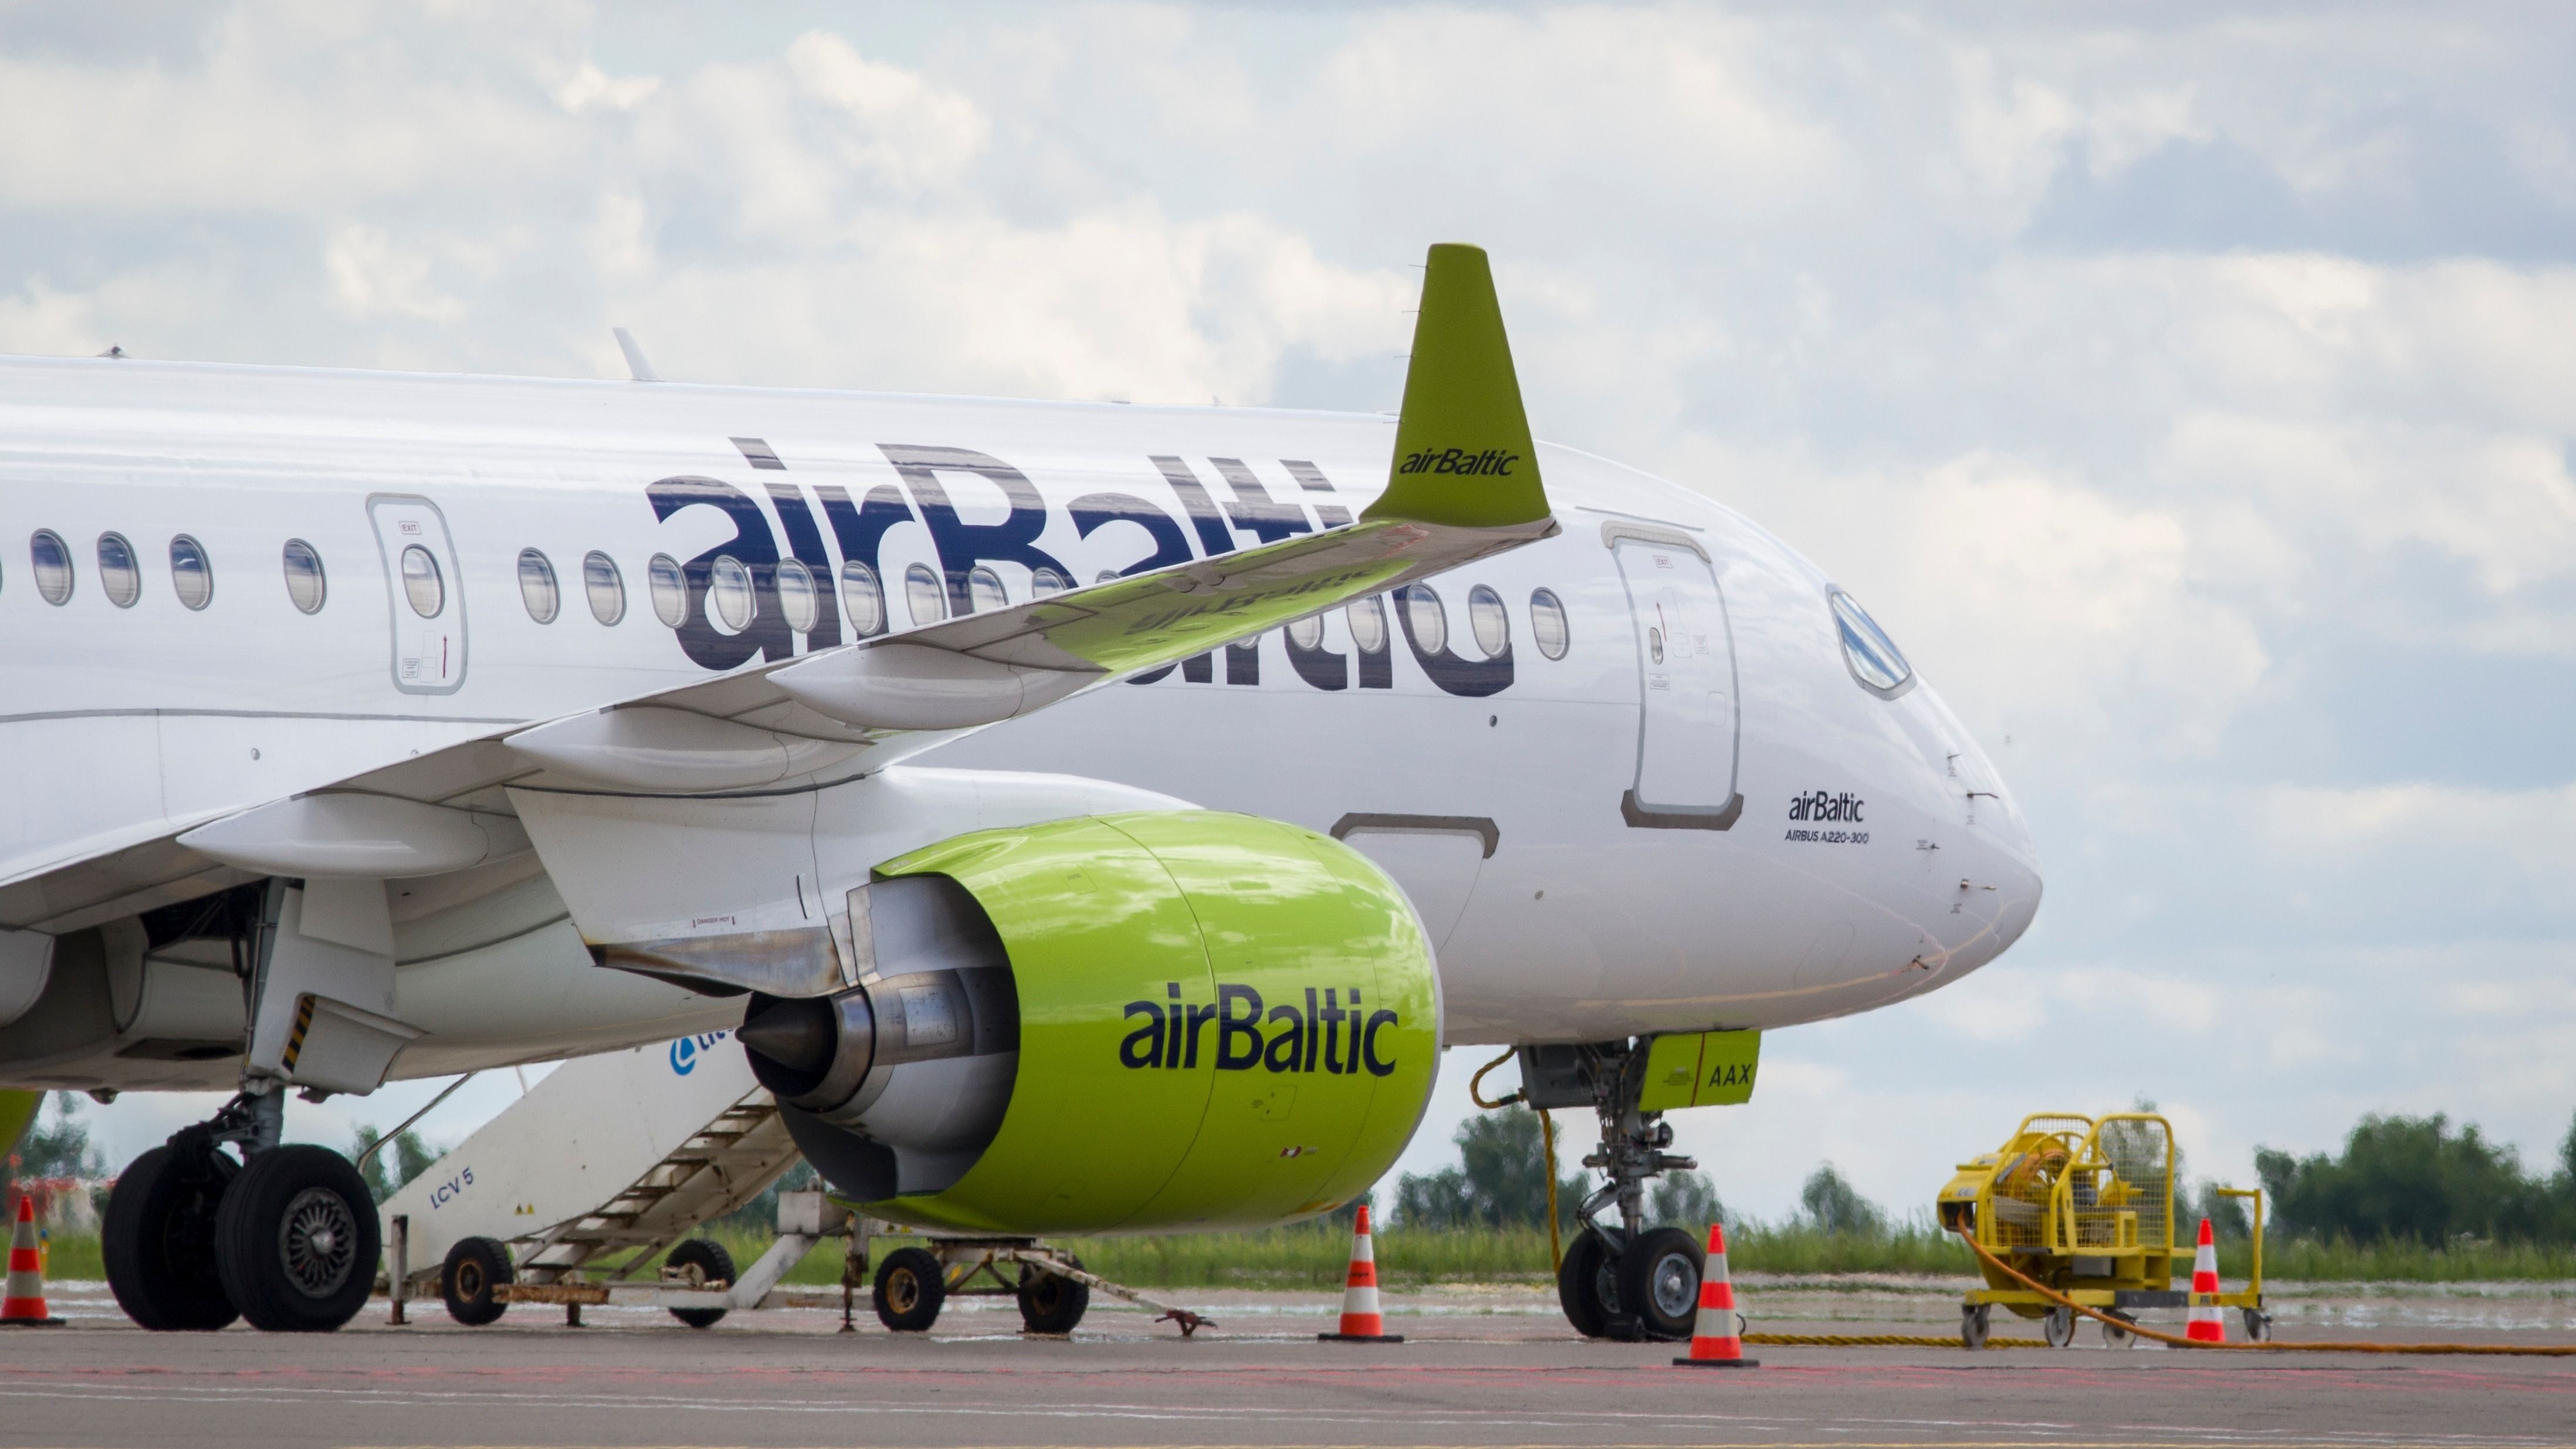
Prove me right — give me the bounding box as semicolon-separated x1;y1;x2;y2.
744;811;1440;1235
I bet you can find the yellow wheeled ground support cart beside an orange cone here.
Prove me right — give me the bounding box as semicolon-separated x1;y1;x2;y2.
1939;1112;2272;1349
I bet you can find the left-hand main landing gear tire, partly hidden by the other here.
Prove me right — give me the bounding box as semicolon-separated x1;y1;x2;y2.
98;1145;242;1333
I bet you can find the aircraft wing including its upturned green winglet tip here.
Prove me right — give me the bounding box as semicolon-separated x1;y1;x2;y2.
0;245;1556;935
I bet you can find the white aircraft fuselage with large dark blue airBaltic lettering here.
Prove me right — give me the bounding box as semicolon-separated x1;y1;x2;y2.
0;360;2037;1086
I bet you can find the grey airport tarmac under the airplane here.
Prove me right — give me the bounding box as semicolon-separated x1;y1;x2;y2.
0;1279;2576;1449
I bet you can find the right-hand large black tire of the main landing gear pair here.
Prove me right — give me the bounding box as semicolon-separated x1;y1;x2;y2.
214;1143;384;1333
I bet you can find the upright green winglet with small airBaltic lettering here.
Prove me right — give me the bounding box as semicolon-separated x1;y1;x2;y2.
1360;242;1548;527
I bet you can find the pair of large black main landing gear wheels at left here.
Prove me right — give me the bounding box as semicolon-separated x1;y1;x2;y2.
100;1084;381;1333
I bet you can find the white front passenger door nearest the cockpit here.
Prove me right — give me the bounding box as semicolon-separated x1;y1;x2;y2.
1605;525;1744;831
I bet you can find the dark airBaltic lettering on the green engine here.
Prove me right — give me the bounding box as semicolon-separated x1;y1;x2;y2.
1118;981;1396;1076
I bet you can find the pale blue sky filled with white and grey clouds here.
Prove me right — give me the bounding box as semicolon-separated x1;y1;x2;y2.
20;0;2576;1215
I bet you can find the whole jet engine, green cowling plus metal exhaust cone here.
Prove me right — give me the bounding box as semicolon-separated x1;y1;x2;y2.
742;811;1440;1235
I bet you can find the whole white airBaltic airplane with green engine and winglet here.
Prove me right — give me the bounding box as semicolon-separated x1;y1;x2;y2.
0;245;2040;1338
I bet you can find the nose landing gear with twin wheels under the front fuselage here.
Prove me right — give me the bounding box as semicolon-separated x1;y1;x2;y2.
1520;1042;1705;1341
